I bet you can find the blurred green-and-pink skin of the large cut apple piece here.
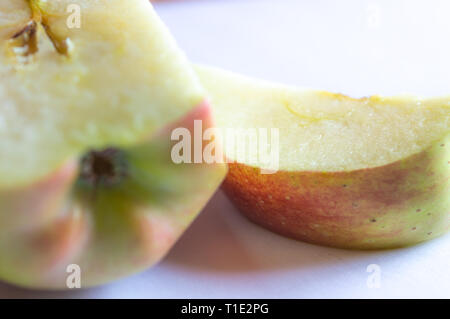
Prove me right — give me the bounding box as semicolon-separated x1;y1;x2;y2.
0;102;227;289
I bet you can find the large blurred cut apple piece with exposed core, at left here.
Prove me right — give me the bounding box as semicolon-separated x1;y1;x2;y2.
0;0;226;289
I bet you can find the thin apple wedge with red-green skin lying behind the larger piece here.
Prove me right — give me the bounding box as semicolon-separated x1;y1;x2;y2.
197;66;450;249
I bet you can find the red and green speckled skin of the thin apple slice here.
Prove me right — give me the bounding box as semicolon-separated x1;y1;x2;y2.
223;135;450;249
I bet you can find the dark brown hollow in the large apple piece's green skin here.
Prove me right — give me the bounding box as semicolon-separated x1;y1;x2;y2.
79;147;128;188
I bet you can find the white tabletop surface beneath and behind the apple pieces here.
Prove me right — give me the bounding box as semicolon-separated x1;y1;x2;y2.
0;0;450;298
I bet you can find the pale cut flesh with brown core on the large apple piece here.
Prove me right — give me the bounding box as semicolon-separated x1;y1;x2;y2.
0;0;204;186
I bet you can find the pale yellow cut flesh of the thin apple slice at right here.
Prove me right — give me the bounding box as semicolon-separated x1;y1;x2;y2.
197;66;450;171
